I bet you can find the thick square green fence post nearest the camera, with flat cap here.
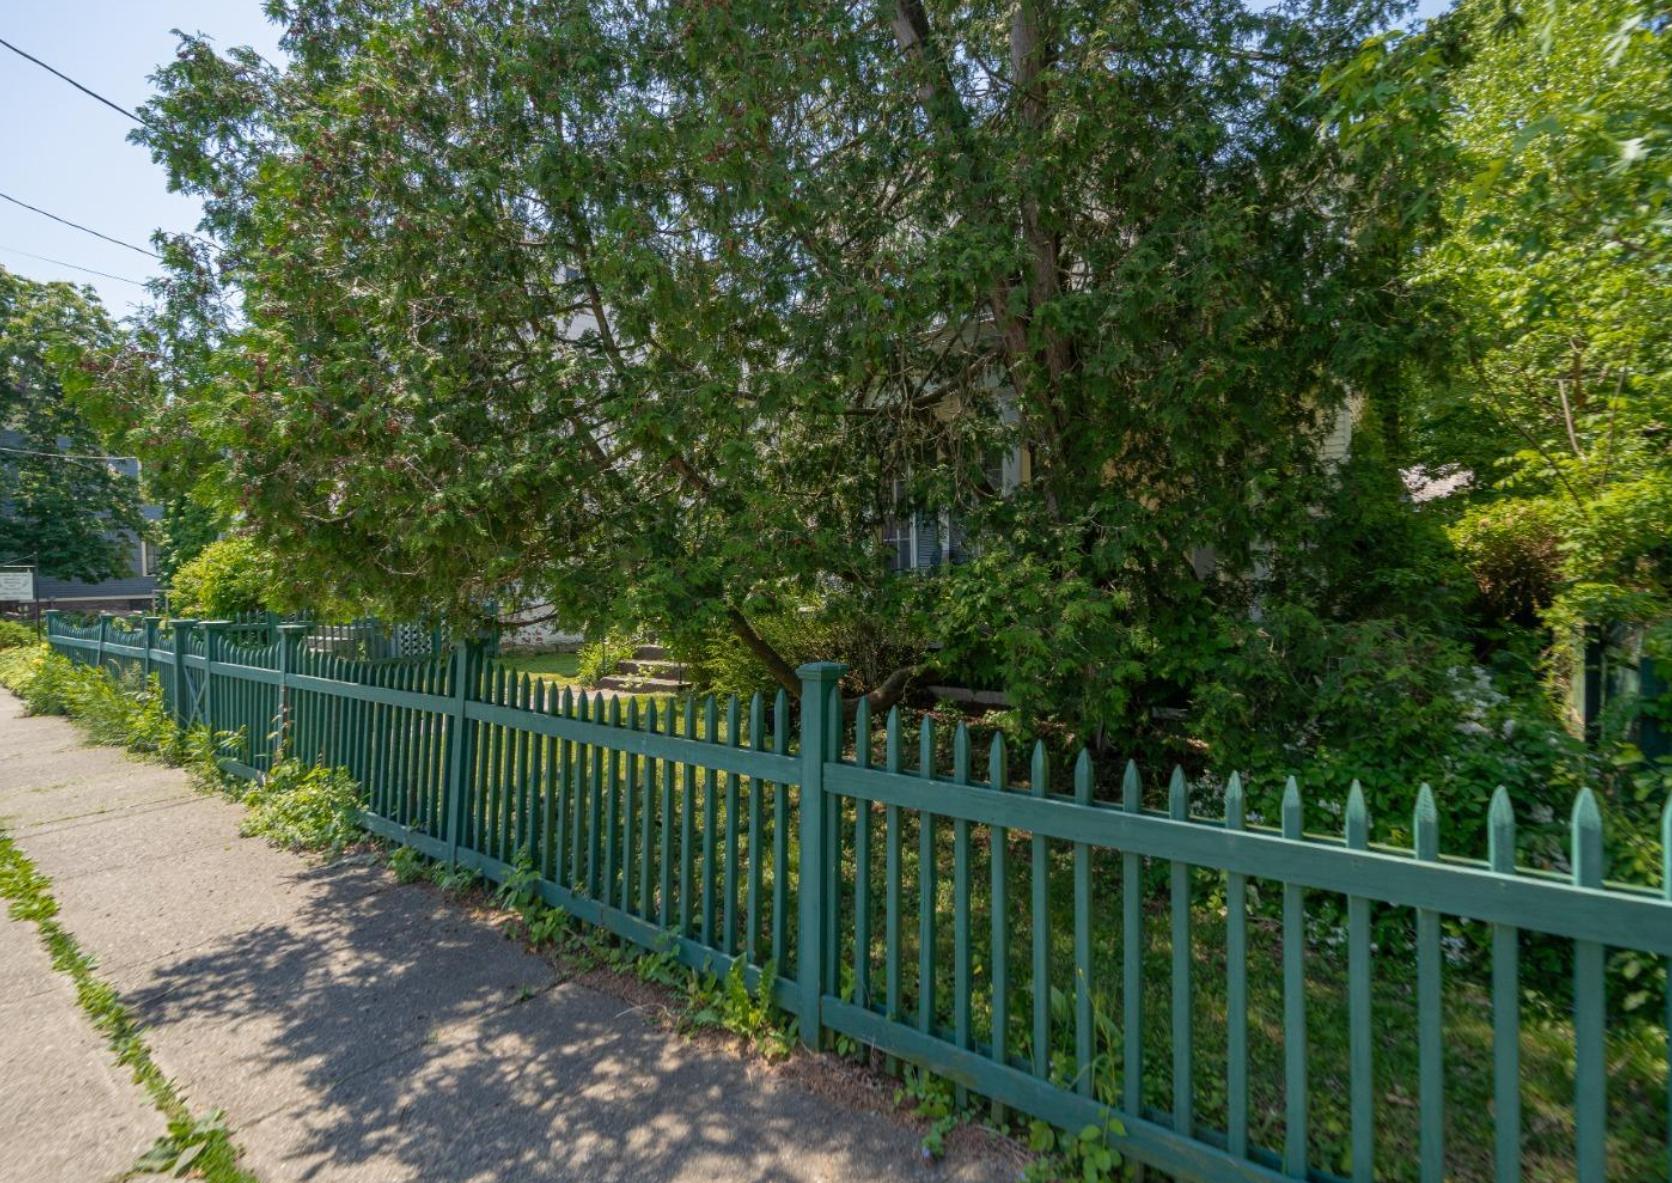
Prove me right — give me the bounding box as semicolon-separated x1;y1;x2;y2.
796;662;848;1048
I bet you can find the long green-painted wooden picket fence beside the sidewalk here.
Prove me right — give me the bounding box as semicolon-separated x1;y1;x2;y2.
48;615;1672;1183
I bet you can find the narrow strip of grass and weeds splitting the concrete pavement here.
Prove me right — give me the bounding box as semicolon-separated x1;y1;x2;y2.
0;832;256;1183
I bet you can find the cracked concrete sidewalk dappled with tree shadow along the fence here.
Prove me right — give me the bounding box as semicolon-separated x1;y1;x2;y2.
0;693;1017;1183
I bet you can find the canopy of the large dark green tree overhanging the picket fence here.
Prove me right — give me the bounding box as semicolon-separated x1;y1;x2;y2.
97;0;1426;720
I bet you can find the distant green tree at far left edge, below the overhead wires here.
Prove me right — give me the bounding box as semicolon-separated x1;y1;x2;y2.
0;267;145;581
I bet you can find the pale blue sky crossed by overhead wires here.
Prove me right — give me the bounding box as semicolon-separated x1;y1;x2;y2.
0;0;1450;316
